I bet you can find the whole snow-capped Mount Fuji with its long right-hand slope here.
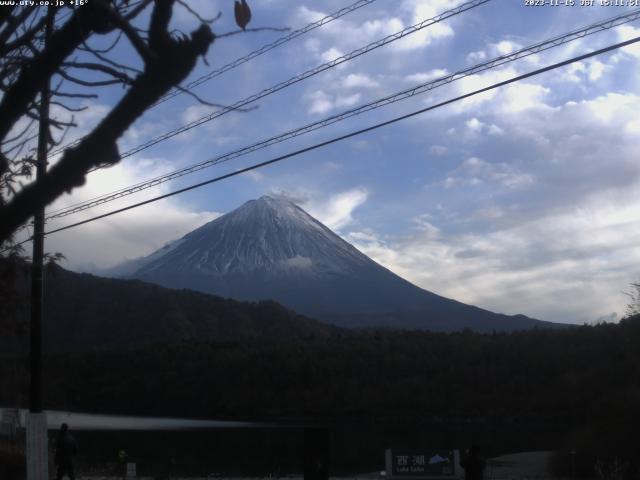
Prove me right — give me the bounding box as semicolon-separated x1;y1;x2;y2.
111;196;554;331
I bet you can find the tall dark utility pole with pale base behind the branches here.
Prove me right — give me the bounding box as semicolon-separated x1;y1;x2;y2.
26;7;54;480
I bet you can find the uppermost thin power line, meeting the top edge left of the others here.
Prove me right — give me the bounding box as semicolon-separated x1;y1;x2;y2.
50;0;377;156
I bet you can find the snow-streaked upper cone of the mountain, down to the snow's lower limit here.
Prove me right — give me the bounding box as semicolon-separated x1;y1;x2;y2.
135;195;371;276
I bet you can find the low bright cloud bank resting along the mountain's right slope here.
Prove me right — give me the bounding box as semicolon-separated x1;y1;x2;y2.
348;203;640;323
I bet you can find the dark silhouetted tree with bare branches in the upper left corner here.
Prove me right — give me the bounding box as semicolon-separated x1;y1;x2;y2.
0;0;257;247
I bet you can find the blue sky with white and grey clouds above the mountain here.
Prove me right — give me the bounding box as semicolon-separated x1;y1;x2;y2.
27;0;640;323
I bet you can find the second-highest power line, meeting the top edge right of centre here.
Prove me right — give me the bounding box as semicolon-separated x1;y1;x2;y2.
47;0;491;161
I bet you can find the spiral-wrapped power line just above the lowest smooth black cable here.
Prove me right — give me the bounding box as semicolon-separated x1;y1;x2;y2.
47;10;640;220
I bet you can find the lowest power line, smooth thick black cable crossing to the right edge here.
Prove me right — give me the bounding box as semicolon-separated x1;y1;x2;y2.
33;36;640;240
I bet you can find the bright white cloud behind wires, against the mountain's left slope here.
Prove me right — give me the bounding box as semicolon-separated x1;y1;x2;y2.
47;158;218;270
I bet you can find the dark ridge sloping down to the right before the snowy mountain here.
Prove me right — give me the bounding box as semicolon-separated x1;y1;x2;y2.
0;268;341;351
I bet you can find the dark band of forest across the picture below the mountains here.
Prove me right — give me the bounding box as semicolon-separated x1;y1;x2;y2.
0;317;640;474
